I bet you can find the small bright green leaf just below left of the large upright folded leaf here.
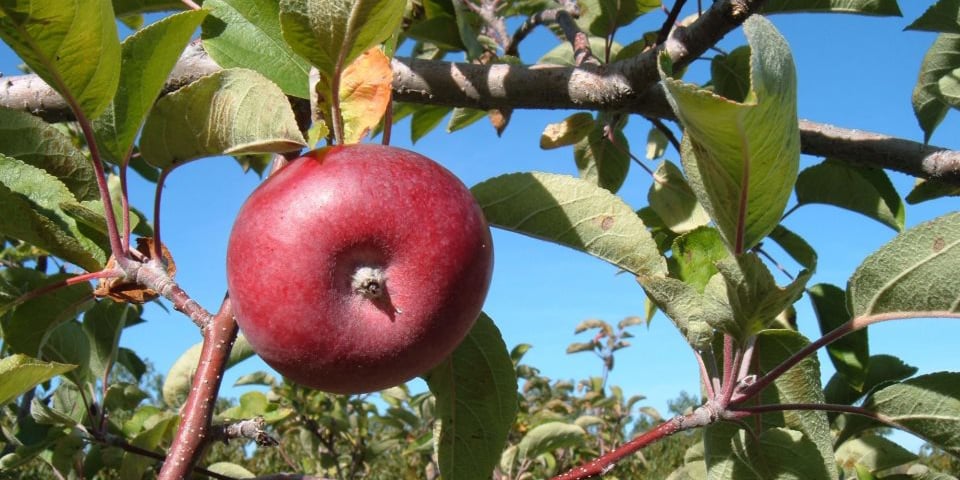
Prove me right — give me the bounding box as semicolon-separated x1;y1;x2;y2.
669;227;730;293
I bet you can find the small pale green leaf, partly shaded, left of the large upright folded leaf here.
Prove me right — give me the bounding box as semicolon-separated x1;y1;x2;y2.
647;160;710;233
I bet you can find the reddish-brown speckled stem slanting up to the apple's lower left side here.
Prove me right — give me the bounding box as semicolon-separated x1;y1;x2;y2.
157;297;237;480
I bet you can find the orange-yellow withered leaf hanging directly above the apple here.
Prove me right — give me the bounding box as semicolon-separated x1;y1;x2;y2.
340;47;393;145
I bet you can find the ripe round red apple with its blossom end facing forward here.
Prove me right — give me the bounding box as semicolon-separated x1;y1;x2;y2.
227;145;493;394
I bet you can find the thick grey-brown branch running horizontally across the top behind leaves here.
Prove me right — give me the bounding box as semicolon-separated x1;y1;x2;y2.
0;0;960;185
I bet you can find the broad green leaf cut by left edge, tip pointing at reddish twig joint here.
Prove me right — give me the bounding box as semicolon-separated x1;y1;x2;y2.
0;155;106;272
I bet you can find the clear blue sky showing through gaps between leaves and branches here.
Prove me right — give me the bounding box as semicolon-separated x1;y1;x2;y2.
0;2;960;454
